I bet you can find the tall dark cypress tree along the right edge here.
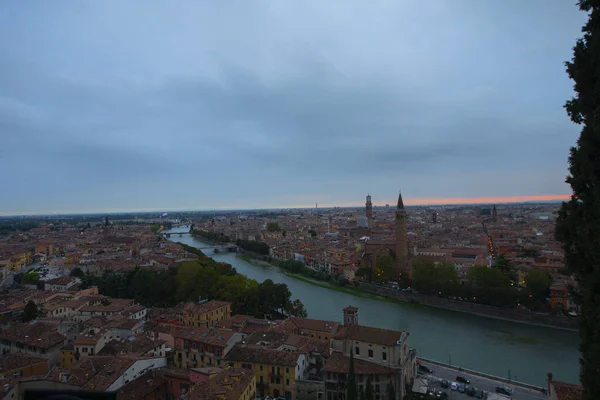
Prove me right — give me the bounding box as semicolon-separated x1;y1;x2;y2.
556;0;600;399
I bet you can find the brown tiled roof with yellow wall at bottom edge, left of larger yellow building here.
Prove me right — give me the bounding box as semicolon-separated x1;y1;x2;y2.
189;368;256;400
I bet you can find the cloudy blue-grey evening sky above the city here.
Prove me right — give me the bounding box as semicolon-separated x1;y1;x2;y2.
0;0;586;214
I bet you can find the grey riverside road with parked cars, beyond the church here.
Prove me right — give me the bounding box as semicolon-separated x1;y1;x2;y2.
421;363;548;400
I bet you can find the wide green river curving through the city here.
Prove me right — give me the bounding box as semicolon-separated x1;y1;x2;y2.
168;227;579;387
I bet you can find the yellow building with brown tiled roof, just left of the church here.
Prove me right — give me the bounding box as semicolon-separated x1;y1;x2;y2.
225;343;308;400
